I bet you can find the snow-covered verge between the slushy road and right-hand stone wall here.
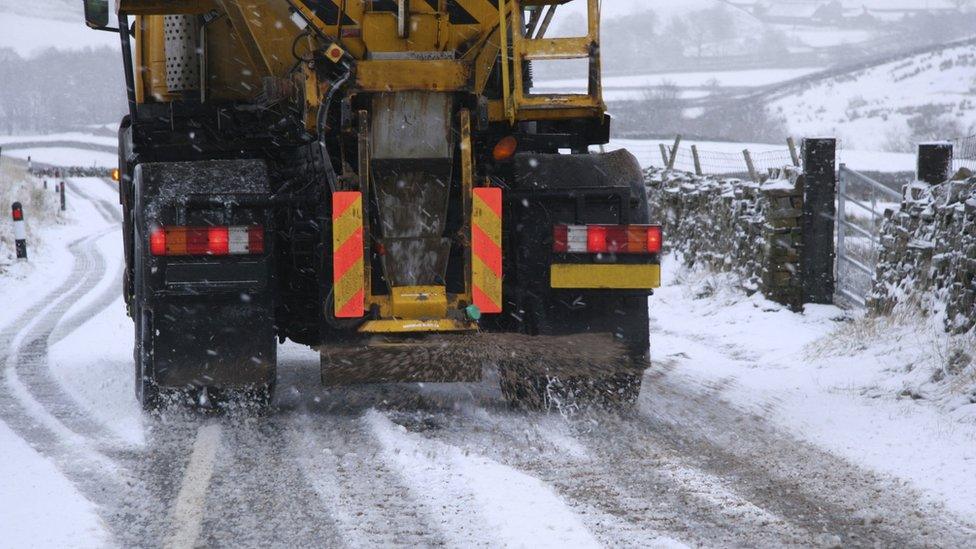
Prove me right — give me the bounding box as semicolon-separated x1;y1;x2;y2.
650;256;976;519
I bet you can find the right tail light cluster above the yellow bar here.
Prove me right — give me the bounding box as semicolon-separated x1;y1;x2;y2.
552;225;662;254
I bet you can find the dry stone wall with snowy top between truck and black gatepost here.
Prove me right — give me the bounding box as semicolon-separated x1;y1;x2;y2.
645;168;803;310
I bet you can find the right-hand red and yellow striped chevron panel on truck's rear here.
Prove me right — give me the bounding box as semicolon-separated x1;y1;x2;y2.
471;187;502;313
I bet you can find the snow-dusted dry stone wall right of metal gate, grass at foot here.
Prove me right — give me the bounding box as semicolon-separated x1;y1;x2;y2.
858;173;976;408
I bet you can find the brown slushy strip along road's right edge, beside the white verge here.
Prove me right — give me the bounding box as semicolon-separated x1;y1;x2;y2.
628;360;976;546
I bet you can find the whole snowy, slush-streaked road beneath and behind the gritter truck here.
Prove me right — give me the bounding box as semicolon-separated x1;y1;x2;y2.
0;179;976;547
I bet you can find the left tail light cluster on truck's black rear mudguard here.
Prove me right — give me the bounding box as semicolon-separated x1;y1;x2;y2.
149;225;264;256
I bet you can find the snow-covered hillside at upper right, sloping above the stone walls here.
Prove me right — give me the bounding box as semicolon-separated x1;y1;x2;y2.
770;44;976;150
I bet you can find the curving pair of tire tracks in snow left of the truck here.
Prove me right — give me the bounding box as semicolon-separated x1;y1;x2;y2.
0;182;175;547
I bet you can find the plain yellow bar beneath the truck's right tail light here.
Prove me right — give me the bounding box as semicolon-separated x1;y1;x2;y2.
549;264;661;290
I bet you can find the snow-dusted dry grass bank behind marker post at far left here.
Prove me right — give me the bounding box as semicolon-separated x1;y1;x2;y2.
0;157;62;274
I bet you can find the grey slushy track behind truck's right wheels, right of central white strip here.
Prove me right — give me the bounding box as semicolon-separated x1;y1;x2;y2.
374;390;792;547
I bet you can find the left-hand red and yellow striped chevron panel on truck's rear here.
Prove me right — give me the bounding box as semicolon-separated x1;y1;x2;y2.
332;191;366;318
